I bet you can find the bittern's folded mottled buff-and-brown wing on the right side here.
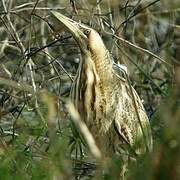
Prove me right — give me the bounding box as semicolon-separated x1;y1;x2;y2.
113;63;152;154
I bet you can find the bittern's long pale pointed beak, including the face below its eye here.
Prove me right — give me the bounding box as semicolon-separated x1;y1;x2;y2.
52;11;88;51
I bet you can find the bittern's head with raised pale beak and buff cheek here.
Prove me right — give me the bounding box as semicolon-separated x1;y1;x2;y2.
52;11;106;55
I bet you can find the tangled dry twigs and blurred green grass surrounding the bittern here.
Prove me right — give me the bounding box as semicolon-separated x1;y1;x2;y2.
0;0;180;180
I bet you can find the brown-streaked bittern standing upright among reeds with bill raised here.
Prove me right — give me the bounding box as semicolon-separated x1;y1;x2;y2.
53;12;152;156
